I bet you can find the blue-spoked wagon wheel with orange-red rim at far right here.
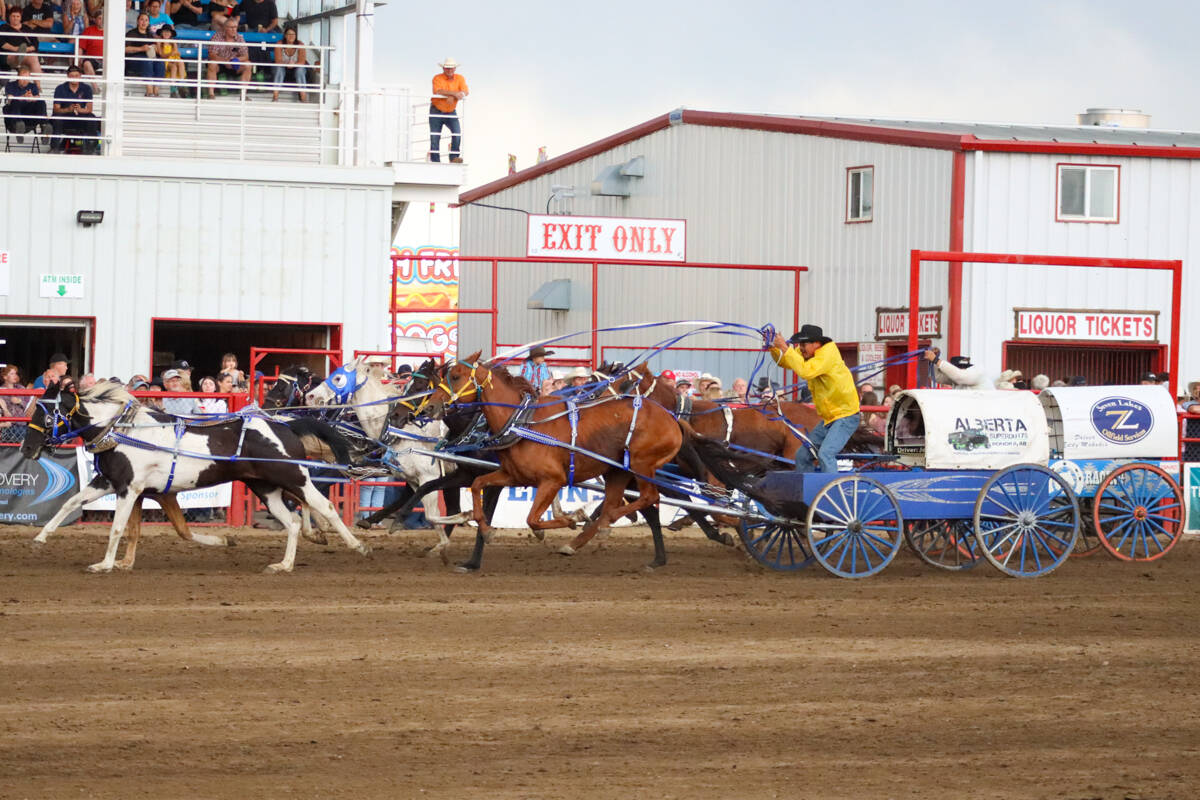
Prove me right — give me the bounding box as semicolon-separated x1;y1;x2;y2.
1092;464;1183;561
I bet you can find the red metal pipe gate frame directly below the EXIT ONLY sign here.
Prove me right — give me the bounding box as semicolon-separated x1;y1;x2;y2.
390;253;809;367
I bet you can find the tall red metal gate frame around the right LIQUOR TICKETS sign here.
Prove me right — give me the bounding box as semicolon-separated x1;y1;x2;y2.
907;249;1183;397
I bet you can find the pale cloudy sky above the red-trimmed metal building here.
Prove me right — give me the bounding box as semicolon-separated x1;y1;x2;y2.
376;0;1200;188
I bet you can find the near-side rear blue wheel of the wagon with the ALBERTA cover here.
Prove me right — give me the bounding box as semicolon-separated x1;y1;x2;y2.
974;464;1079;578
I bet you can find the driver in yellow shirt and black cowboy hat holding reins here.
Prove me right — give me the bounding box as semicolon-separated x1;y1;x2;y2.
770;325;859;473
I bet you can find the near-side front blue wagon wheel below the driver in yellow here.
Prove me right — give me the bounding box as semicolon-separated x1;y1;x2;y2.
808;475;904;578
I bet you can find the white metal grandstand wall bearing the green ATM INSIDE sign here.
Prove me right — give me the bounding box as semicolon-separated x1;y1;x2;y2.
0;157;391;375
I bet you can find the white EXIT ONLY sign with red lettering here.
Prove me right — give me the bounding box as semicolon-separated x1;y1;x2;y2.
526;213;688;261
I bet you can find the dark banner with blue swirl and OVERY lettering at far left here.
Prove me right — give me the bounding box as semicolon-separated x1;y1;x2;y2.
0;447;80;525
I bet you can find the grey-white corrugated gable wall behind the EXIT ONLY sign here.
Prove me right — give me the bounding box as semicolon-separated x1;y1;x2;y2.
460;125;952;359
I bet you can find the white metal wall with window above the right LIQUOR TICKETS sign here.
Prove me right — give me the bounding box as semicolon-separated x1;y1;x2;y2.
962;152;1200;385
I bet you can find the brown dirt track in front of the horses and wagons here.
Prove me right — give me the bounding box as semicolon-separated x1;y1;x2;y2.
0;525;1200;800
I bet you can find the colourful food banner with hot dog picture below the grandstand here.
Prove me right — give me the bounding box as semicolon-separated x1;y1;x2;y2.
391;245;458;355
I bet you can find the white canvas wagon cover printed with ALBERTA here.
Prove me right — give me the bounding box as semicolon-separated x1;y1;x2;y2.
888;389;1050;469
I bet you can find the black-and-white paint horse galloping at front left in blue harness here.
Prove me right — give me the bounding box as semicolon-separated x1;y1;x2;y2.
22;381;371;572
